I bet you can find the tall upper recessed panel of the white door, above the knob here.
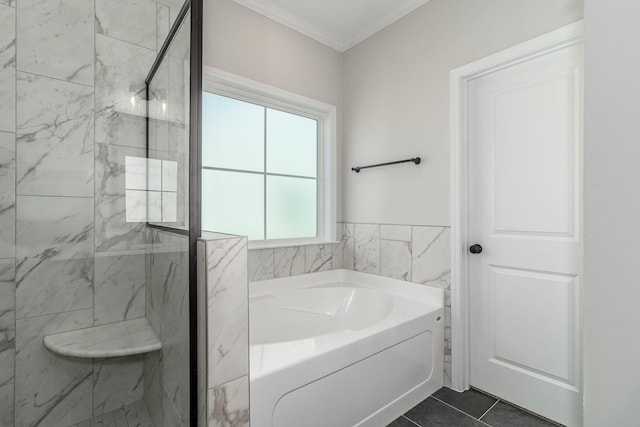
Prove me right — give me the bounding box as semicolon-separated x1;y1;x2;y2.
488;73;575;235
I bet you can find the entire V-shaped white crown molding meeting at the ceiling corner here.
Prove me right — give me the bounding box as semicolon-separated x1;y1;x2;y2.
234;0;429;52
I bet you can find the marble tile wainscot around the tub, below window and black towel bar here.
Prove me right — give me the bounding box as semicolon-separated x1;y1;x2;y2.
249;223;451;385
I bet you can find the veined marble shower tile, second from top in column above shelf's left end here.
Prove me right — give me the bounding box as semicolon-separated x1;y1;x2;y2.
16;72;94;197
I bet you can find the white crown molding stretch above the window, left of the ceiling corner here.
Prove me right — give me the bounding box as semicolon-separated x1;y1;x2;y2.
234;0;345;52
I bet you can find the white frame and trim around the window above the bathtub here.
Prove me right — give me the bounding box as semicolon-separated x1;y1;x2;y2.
201;65;338;249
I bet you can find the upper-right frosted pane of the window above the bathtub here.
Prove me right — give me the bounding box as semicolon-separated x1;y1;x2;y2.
267;108;318;178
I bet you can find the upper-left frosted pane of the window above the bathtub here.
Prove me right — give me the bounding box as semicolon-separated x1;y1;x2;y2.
202;92;264;172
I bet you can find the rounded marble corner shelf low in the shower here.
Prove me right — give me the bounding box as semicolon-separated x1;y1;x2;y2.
44;318;161;358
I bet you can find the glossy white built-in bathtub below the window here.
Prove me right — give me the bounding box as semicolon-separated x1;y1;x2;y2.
249;270;444;427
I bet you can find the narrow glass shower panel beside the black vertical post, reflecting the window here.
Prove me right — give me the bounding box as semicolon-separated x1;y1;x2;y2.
144;7;191;427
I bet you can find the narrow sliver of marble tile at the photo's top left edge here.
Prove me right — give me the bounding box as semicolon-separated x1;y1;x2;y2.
0;5;16;132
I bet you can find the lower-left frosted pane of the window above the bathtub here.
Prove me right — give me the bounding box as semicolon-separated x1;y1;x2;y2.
202;170;264;240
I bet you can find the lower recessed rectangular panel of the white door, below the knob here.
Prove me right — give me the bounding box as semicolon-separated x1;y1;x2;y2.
489;266;578;384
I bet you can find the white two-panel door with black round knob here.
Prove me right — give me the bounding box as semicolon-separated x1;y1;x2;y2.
467;39;582;426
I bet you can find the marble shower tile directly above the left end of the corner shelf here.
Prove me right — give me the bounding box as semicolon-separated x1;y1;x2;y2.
16;196;93;318
